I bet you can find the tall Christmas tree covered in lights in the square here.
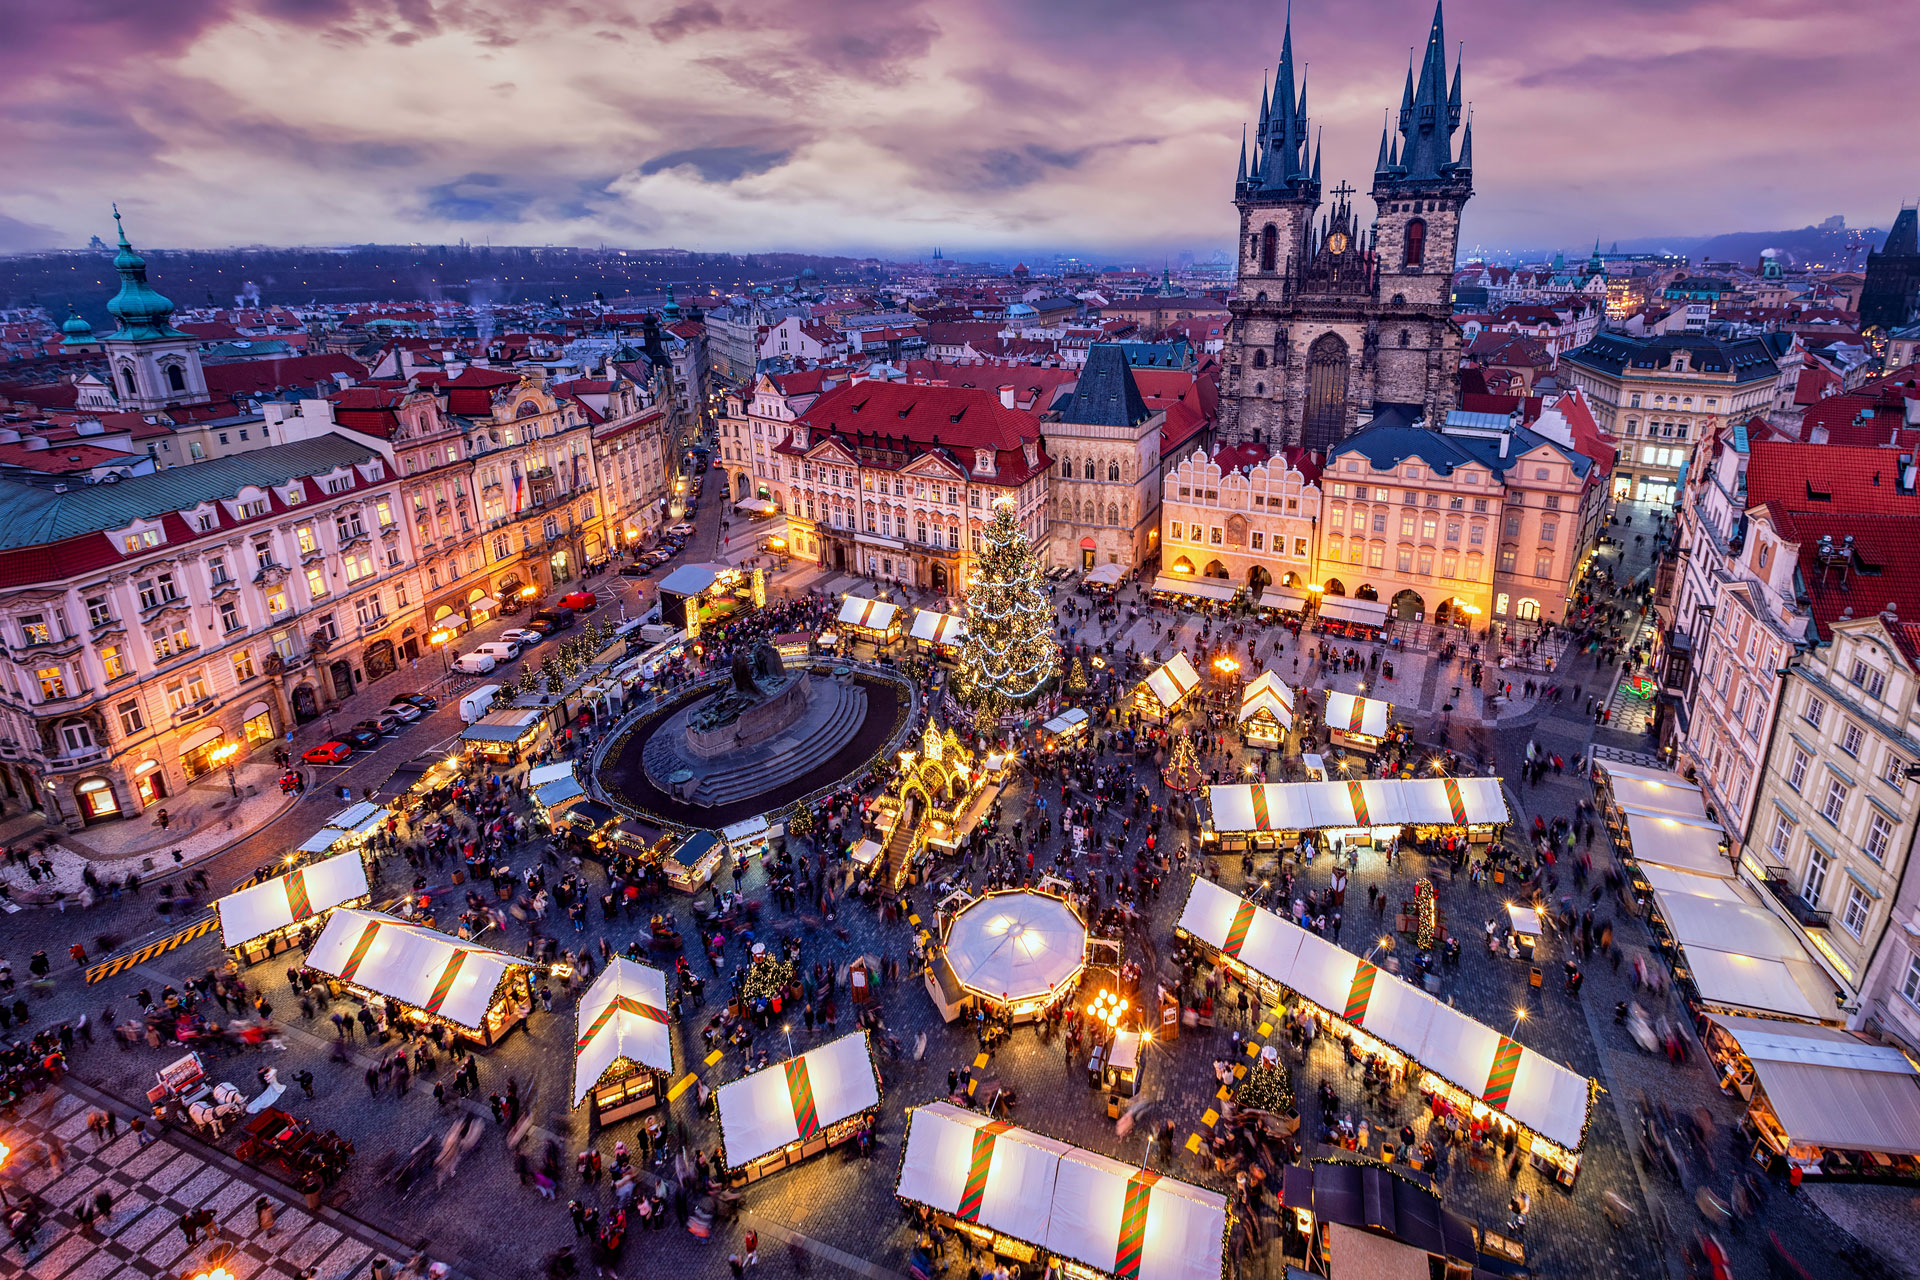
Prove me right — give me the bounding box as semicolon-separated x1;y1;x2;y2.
960;499;1060;716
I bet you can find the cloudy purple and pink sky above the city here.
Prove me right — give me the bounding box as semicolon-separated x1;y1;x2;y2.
0;0;1920;255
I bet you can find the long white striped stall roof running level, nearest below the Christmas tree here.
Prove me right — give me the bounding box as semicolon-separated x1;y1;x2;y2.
1208;777;1507;833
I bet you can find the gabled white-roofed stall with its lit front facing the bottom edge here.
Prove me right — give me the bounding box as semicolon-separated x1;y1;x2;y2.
574;956;674;1126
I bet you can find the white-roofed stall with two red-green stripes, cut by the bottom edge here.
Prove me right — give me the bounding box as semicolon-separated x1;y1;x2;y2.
895;1102;1231;1280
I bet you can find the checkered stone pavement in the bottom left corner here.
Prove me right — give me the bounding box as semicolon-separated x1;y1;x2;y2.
0;1088;407;1280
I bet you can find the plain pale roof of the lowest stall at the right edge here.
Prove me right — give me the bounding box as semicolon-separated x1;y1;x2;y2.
1713;1013;1920;1155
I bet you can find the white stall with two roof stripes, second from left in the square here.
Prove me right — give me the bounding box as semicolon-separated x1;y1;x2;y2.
307;908;534;1044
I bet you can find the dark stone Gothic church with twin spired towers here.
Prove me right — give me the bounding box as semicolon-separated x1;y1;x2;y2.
1221;6;1473;453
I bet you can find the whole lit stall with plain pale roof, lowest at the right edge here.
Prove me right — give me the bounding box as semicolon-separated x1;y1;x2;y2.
1707;1013;1920;1184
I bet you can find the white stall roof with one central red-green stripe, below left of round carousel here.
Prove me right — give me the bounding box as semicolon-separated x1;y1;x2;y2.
716;1031;879;1169
